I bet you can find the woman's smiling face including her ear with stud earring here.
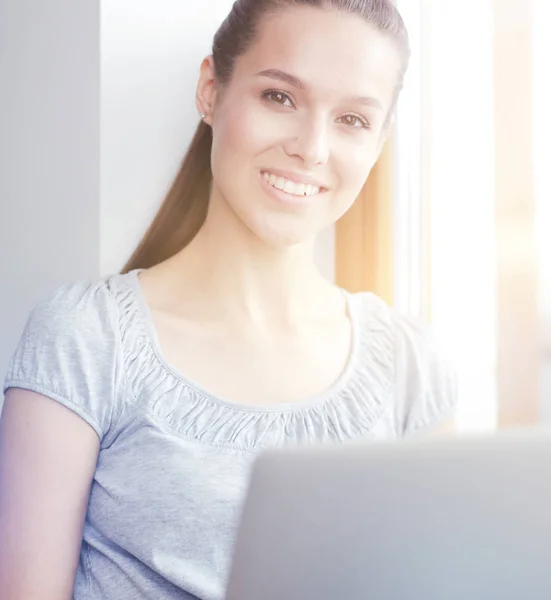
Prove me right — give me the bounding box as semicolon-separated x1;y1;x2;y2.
198;7;400;246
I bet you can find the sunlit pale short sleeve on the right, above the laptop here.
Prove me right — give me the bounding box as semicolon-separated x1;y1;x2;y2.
395;316;458;434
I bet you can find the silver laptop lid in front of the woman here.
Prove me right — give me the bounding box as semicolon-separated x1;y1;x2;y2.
227;430;551;600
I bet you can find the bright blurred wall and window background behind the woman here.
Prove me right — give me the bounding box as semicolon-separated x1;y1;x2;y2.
0;0;551;431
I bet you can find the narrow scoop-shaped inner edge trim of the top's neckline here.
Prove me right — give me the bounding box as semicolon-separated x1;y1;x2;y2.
127;269;361;413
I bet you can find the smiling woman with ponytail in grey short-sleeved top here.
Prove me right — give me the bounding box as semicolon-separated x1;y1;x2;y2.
0;0;456;600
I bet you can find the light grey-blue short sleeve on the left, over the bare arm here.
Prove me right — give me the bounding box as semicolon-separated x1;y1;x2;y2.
3;281;123;440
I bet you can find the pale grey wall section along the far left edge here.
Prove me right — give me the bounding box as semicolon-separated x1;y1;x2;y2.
0;0;100;406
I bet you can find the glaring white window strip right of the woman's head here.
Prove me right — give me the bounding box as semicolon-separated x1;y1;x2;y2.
395;0;497;431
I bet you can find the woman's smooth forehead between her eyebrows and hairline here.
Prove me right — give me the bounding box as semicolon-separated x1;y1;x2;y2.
236;7;400;105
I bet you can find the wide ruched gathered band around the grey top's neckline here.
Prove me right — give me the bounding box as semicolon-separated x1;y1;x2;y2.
109;269;395;449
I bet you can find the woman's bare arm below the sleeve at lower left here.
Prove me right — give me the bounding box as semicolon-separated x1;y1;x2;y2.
0;388;99;600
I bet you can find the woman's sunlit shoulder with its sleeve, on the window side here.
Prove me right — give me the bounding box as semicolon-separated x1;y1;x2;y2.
353;293;458;433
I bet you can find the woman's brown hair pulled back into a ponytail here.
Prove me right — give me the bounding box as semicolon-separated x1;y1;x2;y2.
122;0;410;273
